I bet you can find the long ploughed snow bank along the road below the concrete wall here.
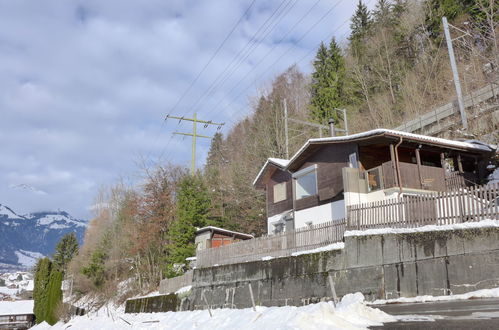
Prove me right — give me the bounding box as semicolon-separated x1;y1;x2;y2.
32;293;396;330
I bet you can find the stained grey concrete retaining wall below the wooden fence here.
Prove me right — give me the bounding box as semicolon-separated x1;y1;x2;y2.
189;228;499;309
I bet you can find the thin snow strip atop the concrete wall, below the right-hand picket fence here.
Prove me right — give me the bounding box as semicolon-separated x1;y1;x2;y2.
345;219;499;237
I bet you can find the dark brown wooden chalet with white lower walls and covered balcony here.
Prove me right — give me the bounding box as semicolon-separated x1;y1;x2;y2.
253;129;496;234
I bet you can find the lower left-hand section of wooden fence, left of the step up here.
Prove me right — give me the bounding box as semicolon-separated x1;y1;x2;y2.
196;219;346;268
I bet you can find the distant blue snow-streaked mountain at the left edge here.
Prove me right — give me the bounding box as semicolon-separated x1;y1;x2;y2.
0;204;87;273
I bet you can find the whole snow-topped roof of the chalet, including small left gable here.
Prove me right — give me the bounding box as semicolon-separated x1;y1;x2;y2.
253;128;495;186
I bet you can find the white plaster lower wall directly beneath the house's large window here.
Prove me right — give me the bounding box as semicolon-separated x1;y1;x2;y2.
295;200;345;228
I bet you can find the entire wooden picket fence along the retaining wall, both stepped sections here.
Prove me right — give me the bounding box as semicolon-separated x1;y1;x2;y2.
196;184;499;268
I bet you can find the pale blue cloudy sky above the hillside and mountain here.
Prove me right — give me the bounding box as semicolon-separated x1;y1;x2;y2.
0;0;372;219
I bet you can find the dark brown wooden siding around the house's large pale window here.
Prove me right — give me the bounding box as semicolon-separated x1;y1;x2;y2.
295;143;358;210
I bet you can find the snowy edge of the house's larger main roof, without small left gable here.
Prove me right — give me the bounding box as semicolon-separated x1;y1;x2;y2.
286;128;494;168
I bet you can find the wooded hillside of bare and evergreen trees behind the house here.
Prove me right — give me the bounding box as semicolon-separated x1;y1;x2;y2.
60;0;499;306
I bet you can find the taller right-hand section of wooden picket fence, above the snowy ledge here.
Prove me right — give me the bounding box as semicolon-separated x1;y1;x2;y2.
347;184;499;230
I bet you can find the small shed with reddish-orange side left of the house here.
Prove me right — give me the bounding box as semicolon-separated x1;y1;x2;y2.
195;226;254;250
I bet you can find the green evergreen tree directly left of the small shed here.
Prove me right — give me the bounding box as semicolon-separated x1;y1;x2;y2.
167;175;210;277
